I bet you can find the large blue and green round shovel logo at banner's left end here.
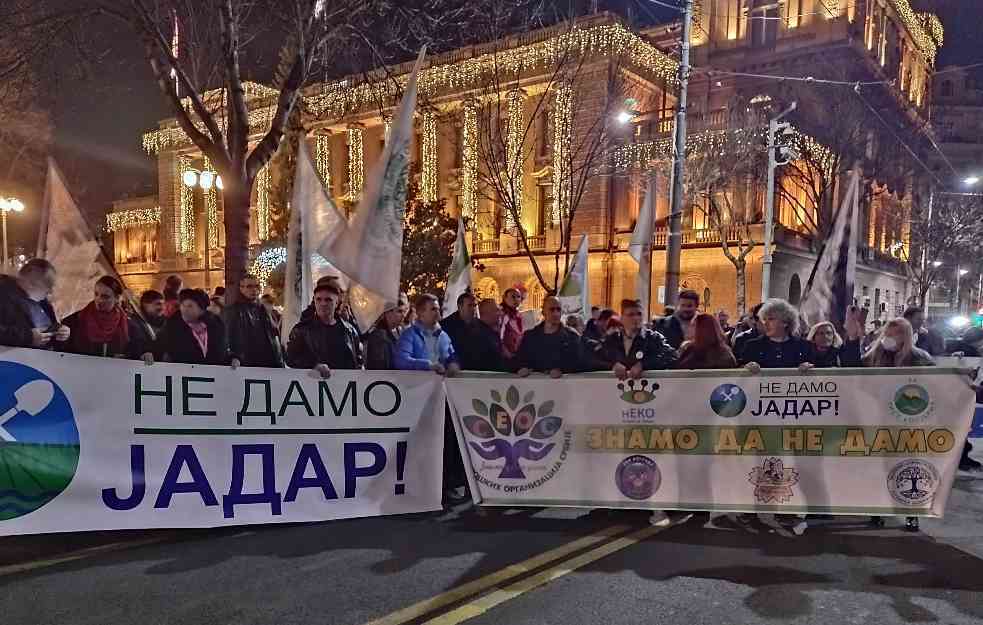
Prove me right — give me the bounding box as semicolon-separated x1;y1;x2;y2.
0;362;79;521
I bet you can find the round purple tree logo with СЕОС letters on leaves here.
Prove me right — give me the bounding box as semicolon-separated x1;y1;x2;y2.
462;386;572;492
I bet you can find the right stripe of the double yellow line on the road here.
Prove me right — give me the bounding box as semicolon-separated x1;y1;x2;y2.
422;527;667;625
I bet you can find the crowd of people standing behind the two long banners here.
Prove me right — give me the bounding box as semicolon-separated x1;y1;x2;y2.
0;259;983;530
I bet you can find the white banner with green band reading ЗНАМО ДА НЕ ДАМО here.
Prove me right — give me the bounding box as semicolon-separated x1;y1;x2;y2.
445;367;975;516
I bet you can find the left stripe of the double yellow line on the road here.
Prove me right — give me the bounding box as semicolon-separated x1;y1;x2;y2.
365;525;631;625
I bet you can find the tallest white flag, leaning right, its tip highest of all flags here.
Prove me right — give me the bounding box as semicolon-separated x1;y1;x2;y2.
318;48;426;329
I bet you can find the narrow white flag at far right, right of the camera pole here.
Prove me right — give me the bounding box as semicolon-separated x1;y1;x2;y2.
799;171;860;328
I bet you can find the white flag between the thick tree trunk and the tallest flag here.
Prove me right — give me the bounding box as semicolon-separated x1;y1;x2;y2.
283;141;348;339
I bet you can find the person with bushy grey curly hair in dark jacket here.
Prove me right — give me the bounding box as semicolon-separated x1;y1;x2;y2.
741;299;814;373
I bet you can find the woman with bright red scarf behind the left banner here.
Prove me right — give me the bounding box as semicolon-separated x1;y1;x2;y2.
65;276;130;358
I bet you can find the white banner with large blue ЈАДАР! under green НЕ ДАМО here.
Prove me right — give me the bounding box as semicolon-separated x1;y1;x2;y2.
0;349;445;535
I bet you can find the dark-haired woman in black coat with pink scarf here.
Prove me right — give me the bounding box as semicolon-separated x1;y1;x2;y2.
149;289;229;365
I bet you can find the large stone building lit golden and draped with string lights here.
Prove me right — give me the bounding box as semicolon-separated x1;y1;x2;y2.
107;0;941;314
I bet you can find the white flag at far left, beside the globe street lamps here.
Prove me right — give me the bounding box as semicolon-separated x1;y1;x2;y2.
37;158;122;319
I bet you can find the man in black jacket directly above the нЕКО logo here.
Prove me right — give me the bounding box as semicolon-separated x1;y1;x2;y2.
600;299;676;380
